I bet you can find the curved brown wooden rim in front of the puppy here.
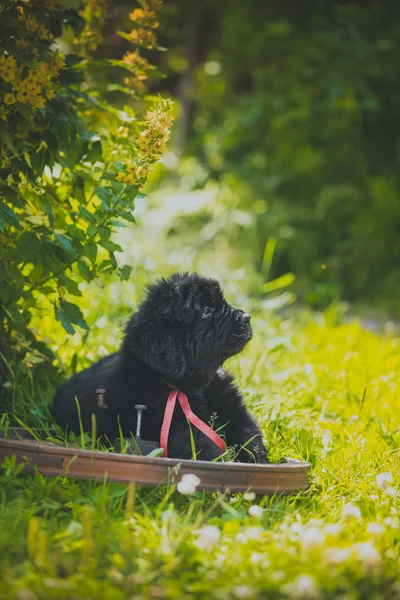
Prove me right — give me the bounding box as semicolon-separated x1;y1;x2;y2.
0;432;311;494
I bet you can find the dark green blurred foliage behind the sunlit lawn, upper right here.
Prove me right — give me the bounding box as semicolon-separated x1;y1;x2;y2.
164;0;400;313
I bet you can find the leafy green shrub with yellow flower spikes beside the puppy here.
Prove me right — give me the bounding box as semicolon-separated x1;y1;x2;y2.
0;0;172;408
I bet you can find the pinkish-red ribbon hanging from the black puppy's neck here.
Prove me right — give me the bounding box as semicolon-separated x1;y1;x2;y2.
160;381;226;458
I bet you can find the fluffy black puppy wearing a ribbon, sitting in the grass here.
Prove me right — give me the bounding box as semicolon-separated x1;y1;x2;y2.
52;273;268;463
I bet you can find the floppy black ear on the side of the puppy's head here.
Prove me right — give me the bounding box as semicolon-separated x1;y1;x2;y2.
125;317;186;379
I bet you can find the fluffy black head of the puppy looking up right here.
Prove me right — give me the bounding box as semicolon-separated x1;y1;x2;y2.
125;273;252;379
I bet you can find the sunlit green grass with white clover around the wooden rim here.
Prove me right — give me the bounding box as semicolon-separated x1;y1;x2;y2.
0;304;400;600
